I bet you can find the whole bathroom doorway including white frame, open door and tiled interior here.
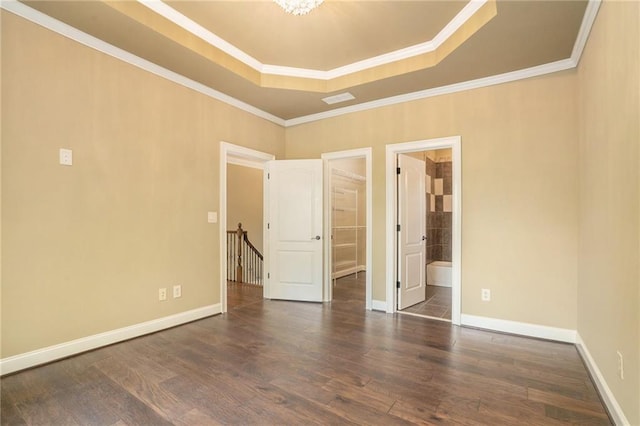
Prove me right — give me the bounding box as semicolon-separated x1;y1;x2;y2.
387;137;461;324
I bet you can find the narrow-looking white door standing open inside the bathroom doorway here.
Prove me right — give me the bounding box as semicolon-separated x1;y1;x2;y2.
398;154;427;310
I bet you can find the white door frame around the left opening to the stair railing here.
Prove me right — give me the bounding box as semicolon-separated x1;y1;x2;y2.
218;141;275;313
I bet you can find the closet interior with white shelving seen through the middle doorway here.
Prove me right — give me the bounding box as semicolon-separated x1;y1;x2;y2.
331;160;366;279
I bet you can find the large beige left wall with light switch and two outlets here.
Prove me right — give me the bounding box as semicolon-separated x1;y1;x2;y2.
1;12;284;358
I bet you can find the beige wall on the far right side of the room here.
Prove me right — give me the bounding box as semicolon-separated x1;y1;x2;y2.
578;1;640;425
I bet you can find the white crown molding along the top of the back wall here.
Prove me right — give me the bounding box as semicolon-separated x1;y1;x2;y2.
284;59;575;127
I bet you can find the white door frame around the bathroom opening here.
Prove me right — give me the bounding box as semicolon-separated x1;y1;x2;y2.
385;136;462;325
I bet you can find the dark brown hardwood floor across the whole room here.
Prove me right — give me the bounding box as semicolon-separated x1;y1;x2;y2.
1;279;611;425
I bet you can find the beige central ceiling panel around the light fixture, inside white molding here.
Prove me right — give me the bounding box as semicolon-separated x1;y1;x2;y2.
166;0;468;71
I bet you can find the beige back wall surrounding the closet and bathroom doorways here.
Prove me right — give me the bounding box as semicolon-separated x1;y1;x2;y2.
286;72;578;329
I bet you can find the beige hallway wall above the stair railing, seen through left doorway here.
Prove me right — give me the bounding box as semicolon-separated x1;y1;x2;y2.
227;164;264;253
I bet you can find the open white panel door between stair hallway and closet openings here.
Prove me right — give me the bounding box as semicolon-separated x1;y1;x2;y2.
266;160;322;302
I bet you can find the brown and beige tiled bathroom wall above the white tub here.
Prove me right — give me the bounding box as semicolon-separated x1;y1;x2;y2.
425;151;452;263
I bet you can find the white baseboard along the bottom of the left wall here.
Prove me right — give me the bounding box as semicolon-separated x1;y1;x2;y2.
0;303;222;375
